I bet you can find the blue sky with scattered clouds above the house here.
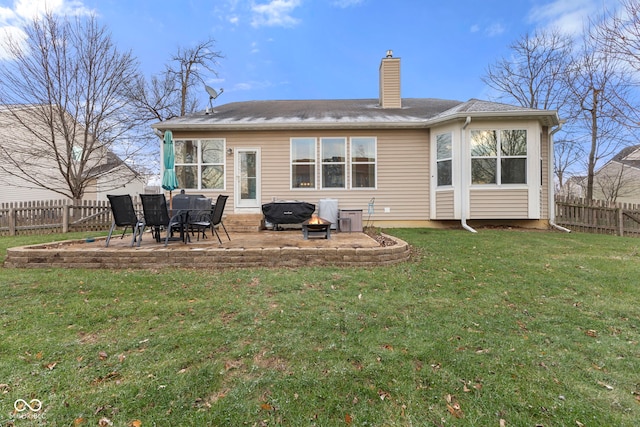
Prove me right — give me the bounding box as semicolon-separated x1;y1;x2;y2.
0;0;618;106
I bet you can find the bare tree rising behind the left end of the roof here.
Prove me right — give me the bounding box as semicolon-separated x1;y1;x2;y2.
130;38;223;121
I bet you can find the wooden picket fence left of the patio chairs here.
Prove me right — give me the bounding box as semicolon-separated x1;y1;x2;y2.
0;200;137;236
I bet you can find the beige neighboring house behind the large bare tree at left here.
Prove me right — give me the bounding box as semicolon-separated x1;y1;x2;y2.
0;106;145;203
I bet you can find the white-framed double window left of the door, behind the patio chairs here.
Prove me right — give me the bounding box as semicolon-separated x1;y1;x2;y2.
174;139;225;190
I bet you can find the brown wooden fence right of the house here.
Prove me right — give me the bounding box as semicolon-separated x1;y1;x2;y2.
556;197;640;237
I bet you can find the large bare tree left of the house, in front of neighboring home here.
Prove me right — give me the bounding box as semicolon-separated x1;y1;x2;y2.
0;13;141;199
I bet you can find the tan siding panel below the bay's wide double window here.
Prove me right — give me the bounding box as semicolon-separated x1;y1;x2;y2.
469;188;529;219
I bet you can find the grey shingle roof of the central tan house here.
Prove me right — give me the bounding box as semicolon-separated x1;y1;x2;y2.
153;98;557;130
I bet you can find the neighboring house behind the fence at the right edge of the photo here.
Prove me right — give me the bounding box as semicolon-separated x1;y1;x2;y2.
583;145;640;204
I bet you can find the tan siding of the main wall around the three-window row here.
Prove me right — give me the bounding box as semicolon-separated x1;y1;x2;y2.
174;129;429;222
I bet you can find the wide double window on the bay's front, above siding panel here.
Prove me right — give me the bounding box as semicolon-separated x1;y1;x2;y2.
470;129;527;184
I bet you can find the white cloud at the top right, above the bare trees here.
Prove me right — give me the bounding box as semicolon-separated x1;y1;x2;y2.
529;0;603;34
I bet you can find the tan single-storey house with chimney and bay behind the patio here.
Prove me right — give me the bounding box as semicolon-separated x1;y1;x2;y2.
153;51;559;228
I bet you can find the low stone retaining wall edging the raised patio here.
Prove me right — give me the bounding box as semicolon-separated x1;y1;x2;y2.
4;237;410;269
